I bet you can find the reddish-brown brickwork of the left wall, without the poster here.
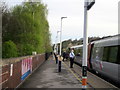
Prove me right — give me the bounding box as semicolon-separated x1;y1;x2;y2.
0;54;45;89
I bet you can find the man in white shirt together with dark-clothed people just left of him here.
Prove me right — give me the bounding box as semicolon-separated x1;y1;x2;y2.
62;49;75;68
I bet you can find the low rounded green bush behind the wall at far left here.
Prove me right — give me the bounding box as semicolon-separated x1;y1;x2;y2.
2;40;18;58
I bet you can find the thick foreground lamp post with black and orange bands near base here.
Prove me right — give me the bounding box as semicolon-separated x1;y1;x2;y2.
82;0;95;88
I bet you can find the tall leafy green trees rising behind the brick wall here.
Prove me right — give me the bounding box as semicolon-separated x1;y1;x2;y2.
2;2;52;56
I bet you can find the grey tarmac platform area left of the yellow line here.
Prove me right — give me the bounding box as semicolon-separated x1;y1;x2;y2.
19;57;90;88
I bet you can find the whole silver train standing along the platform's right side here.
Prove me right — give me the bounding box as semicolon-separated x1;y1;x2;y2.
71;35;120;85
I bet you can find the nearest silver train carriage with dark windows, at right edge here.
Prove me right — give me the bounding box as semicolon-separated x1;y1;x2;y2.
91;35;120;82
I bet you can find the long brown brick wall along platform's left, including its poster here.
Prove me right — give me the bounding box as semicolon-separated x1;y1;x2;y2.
0;53;50;89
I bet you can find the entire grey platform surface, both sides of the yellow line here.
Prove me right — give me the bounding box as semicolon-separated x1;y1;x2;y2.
19;56;118;90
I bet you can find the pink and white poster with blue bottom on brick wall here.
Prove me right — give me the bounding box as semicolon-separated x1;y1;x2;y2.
21;57;32;80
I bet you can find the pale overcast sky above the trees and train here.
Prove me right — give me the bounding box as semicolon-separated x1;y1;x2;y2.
2;0;120;43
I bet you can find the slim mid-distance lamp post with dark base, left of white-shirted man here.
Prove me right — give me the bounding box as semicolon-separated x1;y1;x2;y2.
58;17;67;72
